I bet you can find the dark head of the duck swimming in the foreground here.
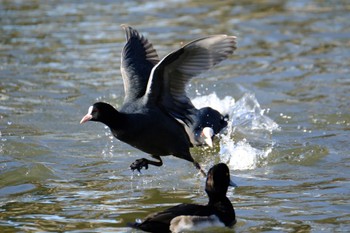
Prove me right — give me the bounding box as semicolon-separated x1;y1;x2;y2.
205;163;237;196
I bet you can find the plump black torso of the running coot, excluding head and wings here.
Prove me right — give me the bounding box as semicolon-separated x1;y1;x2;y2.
114;102;190;157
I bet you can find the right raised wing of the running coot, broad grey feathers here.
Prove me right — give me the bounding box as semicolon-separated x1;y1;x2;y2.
145;35;236;124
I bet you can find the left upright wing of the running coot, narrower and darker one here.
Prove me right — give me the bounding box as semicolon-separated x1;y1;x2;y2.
120;24;159;102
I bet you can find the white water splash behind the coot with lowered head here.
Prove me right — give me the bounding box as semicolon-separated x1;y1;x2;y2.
192;93;279;170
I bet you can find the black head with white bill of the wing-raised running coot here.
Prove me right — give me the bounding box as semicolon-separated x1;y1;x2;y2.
80;102;117;124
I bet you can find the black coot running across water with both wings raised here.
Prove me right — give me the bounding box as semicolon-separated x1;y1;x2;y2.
80;26;236;174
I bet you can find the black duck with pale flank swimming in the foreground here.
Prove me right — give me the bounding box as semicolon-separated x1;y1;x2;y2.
129;163;236;233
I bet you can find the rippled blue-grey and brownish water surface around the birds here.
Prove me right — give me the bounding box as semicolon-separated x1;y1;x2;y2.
0;0;350;232
